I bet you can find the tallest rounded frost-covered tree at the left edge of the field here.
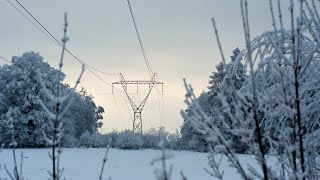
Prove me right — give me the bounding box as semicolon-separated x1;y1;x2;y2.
0;52;64;147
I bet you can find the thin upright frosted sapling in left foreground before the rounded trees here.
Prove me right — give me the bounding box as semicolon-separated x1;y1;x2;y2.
37;14;84;180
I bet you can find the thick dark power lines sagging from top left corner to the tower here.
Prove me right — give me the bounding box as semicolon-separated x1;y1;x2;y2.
7;0;118;76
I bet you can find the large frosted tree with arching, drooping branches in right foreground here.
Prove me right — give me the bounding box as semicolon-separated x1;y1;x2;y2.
182;0;320;179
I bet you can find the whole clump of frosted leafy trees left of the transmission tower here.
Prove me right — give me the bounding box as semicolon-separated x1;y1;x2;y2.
0;51;104;147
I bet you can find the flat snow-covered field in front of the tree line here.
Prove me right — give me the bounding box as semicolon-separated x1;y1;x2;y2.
0;148;264;180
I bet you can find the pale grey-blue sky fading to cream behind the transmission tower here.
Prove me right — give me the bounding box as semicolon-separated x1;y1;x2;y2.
0;0;294;132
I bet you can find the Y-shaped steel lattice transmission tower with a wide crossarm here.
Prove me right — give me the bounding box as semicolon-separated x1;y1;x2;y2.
112;73;163;133
